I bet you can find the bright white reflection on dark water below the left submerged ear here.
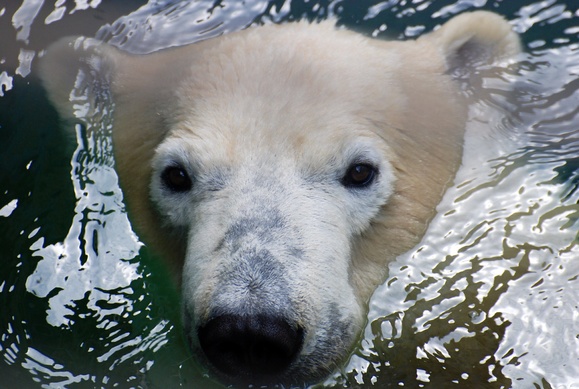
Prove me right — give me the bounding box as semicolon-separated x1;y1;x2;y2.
26;115;142;327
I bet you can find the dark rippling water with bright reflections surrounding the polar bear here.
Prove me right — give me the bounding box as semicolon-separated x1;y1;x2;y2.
0;0;579;389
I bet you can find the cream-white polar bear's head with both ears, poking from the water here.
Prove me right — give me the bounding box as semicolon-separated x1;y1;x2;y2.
40;11;520;384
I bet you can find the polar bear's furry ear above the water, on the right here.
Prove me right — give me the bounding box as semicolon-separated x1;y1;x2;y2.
420;11;521;77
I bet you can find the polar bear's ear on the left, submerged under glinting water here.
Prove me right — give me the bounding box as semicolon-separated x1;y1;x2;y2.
39;37;125;120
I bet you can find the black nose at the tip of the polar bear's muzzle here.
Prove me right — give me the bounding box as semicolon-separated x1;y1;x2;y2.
198;315;303;382
